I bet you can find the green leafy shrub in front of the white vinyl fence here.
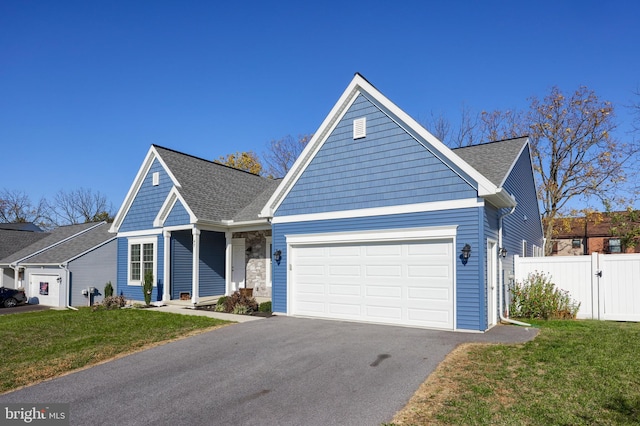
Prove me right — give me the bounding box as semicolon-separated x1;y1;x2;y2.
509;272;580;319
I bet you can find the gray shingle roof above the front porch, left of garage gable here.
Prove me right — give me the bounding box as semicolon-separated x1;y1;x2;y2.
154;145;279;222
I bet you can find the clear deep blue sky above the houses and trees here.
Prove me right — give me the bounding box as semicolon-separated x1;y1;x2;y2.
0;0;640;209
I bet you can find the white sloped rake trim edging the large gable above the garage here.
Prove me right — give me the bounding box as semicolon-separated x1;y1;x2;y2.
261;74;504;217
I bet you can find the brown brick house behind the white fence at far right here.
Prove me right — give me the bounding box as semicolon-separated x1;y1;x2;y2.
551;212;640;256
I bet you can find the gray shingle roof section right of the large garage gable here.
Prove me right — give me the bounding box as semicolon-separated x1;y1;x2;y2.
453;137;528;188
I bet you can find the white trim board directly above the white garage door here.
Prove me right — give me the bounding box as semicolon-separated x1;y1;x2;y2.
285;225;458;245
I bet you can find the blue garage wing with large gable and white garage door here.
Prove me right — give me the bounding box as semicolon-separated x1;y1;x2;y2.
258;74;543;331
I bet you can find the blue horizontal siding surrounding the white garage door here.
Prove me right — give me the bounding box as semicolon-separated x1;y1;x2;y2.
272;207;486;330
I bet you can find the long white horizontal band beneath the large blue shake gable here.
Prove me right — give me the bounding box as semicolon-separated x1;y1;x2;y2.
272;198;484;223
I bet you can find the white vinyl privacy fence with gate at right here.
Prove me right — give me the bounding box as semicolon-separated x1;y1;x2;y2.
514;253;640;321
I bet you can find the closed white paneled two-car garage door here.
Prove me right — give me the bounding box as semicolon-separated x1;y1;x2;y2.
289;239;454;329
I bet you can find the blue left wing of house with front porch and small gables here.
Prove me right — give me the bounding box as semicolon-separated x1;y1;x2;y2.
111;145;278;305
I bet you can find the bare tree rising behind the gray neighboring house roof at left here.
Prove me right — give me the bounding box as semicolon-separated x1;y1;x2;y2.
51;188;113;225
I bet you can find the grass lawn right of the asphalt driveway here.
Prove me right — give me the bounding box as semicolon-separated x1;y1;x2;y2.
393;320;640;425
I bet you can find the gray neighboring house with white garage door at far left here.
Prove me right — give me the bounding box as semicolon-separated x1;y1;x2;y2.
0;222;116;307
